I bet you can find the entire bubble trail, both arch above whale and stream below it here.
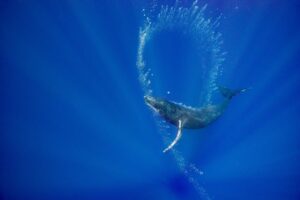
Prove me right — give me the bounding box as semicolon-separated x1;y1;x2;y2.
136;1;225;200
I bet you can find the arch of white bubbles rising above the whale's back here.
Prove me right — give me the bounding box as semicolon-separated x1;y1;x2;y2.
136;1;225;103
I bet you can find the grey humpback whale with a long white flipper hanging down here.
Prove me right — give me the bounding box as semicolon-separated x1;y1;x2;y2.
144;86;247;153
